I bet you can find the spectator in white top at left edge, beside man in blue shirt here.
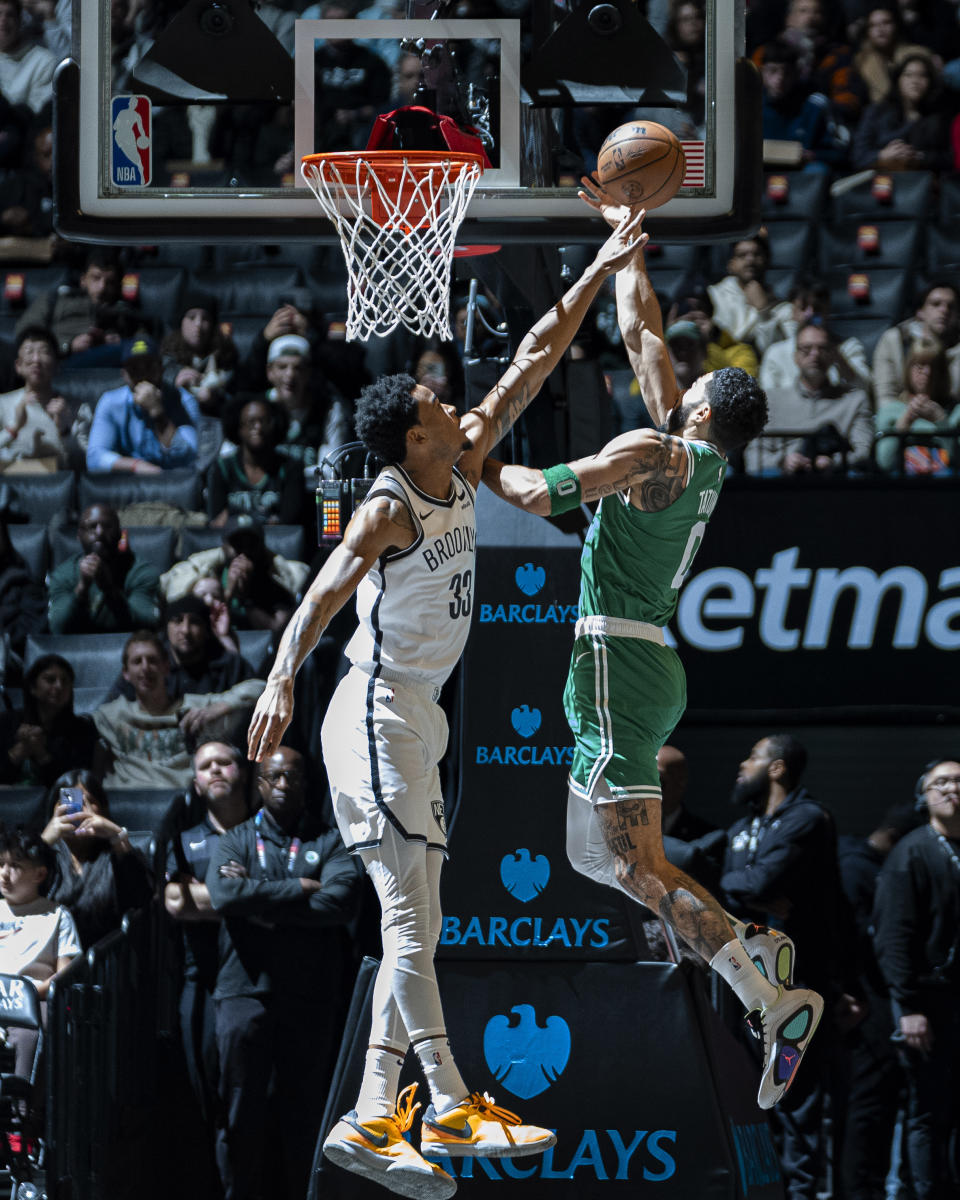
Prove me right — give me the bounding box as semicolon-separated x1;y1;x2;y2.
0;325;66;469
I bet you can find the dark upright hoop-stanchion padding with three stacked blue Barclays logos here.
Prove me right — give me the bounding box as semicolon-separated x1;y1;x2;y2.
437;511;646;962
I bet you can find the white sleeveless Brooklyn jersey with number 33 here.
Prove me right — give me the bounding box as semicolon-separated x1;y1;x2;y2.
346;466;476;686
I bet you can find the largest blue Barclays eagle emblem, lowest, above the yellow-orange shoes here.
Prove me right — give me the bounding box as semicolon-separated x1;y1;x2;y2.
484;1004;570;1100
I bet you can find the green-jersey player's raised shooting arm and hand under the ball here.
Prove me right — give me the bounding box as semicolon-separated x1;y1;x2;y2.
580;176;680;425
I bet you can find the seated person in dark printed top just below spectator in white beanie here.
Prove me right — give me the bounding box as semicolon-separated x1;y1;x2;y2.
206;397;304;526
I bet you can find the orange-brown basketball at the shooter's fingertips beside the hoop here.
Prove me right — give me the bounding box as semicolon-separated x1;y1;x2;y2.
596;121;686;210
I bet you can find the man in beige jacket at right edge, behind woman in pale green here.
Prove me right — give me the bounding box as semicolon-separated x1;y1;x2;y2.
871;280;960;410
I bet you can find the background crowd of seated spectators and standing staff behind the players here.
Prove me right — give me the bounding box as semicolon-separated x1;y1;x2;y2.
0;0;960;1200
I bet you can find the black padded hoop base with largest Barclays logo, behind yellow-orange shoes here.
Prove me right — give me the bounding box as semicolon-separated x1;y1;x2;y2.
311;962;782;1200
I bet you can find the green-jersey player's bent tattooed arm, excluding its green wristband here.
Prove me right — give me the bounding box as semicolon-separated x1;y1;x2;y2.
484;430;688;516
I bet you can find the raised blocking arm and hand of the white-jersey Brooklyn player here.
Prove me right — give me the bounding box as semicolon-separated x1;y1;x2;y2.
458;212;647;484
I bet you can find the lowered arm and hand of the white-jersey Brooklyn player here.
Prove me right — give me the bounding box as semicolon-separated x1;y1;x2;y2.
247;496;416;762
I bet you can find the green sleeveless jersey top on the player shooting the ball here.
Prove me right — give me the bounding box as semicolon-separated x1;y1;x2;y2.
580;442;727;625
